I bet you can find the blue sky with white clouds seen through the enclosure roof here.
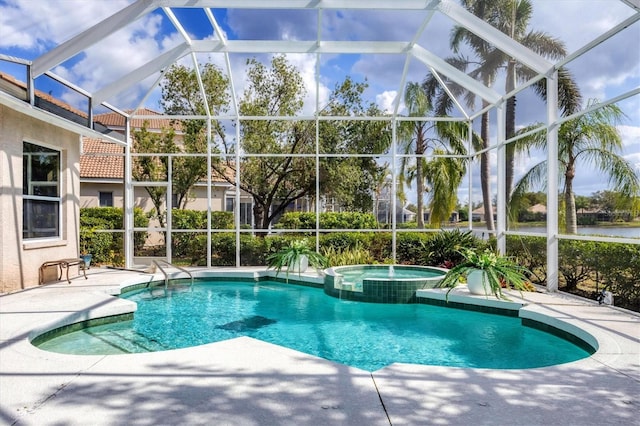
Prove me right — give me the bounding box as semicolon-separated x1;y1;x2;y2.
0;0;640;202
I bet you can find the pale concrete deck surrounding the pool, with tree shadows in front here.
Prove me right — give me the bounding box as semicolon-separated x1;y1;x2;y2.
0;269;640;426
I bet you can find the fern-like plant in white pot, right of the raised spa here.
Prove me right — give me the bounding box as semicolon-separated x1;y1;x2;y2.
438;249;528;300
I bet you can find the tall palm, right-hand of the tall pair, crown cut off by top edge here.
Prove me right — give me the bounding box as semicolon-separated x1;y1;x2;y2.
451;0;566;205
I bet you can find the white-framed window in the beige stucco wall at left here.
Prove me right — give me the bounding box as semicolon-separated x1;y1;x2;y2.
22;142;62;240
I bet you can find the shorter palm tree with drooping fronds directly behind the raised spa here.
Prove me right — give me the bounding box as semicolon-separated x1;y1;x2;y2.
398;82;468;228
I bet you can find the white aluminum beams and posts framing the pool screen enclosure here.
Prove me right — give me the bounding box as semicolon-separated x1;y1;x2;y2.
0;0;640;291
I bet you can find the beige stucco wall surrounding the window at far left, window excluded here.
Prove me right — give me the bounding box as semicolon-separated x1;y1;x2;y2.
0;105;80;292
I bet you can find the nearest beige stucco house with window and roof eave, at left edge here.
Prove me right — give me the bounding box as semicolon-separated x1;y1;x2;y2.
0;73;122;292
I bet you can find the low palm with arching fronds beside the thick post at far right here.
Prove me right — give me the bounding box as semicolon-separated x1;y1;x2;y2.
512;100;640;234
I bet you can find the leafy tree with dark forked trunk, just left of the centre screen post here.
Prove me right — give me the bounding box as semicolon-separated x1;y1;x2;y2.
232;56;315;229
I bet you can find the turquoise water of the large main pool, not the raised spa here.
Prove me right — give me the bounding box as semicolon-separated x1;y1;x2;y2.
39;281;589;371
